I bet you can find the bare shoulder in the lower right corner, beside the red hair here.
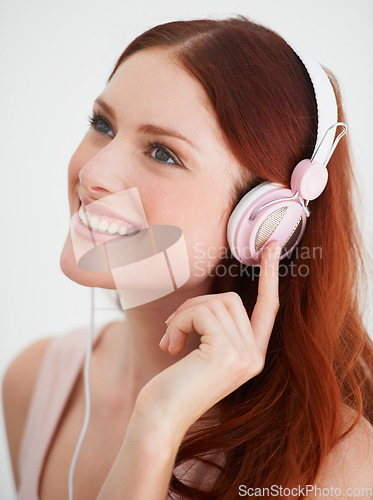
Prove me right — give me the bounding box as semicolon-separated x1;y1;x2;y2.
315;406;373;498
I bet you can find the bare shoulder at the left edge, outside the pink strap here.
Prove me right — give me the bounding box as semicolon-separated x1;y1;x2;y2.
2;336;54;487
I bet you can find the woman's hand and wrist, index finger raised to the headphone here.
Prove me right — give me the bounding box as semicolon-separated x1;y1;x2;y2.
135;243;279;440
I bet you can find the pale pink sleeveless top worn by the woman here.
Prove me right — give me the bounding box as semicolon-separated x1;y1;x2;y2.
17;323;225;500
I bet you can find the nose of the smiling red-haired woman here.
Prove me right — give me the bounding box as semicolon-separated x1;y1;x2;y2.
79;147;130;198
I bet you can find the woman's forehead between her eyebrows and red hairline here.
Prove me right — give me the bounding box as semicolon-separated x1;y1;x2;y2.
101;49;221;143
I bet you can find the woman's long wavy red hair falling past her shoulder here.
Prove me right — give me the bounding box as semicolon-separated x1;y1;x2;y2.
109;16;373;500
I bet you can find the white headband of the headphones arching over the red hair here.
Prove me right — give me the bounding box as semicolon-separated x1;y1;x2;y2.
284;39;338;166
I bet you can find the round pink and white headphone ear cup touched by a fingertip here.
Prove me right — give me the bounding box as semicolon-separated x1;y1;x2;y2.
227;182;307;267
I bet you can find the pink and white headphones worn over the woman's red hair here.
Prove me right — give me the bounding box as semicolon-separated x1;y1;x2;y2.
227;44;347;266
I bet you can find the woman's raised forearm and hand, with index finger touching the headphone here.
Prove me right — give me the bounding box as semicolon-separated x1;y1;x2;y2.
97;243;279;500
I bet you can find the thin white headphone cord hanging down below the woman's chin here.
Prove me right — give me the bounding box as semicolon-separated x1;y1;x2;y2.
69;287;94;500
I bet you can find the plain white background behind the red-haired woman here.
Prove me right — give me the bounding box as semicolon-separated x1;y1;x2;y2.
0;0;373;500
